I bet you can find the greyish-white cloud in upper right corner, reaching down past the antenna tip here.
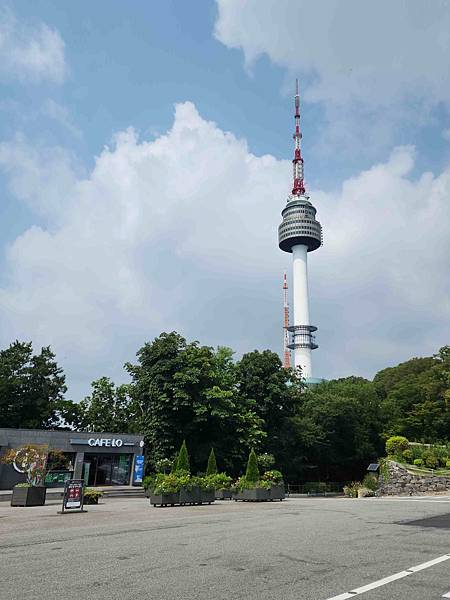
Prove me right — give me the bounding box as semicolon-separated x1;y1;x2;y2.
214;0;450;157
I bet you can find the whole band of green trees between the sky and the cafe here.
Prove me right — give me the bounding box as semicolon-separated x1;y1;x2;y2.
0;332;450;482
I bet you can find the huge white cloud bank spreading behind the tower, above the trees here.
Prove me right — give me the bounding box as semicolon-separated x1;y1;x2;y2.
0;102;450;397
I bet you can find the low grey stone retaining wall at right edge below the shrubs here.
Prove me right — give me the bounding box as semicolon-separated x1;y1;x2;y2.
378;461;450;496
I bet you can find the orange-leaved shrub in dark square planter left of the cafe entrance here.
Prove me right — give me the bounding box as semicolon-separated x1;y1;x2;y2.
2;444;48;506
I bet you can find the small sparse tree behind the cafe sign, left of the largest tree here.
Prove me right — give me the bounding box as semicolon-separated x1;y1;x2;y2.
78;377;139;433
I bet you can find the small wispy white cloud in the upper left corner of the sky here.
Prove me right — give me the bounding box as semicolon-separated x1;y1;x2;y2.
0;9;67;83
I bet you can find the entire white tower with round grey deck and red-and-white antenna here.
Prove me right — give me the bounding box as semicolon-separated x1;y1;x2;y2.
278;81;323;381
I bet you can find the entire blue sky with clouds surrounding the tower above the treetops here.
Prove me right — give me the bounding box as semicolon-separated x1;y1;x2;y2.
0;0;450;399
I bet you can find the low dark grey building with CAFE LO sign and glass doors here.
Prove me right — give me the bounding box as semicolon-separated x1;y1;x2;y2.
0;429;144;490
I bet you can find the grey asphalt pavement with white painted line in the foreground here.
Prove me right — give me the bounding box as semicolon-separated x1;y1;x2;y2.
0;497;450;600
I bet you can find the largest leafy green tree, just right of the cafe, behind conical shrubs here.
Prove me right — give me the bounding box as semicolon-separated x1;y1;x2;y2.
126;332;265;473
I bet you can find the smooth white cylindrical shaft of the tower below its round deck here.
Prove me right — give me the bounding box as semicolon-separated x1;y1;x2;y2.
292;245;312;379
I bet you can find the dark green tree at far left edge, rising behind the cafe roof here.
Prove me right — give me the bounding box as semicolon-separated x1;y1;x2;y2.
0;341;70;429
